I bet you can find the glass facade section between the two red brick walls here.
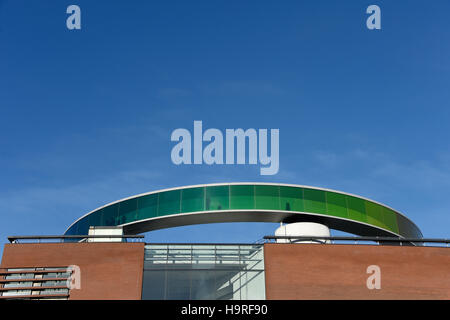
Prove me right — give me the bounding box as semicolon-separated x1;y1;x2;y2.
142;244;265;300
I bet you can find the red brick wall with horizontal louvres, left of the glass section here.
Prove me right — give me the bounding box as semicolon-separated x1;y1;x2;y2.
1;243;144;300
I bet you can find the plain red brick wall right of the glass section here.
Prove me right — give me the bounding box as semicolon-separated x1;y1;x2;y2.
264;243;450;299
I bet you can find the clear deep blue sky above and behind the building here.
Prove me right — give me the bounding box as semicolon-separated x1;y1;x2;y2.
0;0;450;255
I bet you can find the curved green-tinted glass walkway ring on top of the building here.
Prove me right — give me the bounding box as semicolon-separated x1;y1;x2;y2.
66;184;422;238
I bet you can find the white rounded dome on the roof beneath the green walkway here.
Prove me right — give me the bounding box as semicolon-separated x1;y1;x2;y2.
275;222;330;243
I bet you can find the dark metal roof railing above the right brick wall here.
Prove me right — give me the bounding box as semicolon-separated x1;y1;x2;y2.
263;236;450;247
